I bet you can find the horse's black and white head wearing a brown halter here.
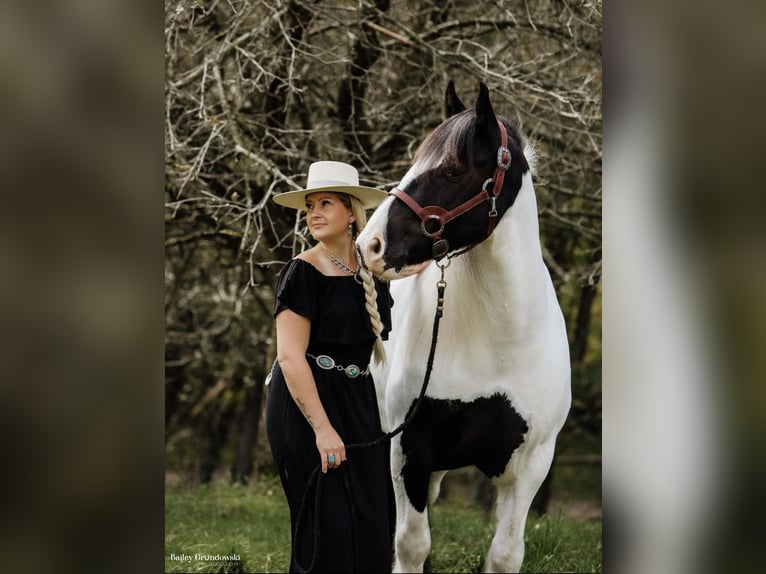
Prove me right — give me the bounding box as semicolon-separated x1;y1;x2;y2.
357;82;529;279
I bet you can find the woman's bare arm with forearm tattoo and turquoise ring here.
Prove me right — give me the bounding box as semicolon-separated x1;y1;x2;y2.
276;309;346;472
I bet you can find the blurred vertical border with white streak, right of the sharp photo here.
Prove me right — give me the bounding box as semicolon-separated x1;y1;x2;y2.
603;2;766;572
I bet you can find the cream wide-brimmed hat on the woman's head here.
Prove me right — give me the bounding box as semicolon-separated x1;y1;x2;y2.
274;161;388;209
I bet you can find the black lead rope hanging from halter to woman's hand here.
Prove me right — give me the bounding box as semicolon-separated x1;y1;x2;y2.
293;258;452;574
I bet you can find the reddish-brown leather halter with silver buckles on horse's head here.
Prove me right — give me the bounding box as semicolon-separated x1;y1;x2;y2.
389;120;511;261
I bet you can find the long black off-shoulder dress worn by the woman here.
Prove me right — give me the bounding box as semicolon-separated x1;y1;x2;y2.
266;259;395;572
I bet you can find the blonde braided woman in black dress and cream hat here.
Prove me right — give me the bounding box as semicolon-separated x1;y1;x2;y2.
266;161;394;572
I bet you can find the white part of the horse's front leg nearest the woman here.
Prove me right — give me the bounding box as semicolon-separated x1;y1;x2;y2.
391;440;431;572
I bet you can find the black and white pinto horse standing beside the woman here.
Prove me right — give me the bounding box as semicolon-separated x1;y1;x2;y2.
358;82;571;572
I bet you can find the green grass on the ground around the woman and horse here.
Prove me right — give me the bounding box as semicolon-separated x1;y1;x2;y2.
165;475;601;573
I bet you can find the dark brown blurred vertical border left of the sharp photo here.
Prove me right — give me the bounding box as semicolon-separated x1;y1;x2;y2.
0;0;164;573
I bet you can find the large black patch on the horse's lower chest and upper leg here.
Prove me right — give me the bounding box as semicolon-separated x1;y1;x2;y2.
401;393;528;512
